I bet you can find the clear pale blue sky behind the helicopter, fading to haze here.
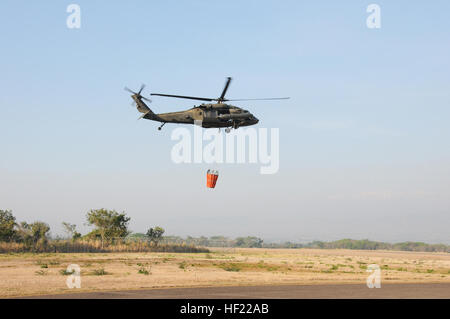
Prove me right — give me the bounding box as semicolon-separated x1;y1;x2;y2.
0;1;450;243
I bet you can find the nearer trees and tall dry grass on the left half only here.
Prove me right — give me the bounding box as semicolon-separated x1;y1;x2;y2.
0;208;208;253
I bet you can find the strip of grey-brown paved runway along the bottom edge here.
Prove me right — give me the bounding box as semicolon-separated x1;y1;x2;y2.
28;283;450;299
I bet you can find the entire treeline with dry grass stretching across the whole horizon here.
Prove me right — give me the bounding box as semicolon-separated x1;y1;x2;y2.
0;208;450;252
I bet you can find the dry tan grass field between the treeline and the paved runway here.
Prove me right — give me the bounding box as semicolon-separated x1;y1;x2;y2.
0;248;450;297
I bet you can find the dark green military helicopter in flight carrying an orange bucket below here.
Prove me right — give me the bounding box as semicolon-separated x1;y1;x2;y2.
125;77;289;133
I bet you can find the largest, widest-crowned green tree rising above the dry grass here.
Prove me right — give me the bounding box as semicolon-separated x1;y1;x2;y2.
86;208;130;246
